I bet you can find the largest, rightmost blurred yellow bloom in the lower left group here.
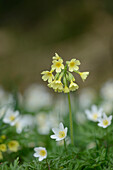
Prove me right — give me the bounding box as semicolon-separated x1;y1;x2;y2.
8;140;19;152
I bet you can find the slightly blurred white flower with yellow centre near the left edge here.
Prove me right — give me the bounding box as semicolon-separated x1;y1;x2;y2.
3;108;19;126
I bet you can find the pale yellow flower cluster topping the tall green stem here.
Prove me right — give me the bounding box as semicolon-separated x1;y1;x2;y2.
41;53;89;93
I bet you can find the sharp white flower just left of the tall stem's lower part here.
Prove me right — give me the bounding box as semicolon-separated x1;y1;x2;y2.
50;123;68;141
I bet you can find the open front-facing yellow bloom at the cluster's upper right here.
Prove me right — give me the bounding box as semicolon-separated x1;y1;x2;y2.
67;59;80;72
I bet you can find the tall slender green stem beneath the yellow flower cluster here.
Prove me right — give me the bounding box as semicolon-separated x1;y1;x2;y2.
68;93;74;145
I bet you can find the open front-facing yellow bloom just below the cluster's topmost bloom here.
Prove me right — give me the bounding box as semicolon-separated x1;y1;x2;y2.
51;59;64;73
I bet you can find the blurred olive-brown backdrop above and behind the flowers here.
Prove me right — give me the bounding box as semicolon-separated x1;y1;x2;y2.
0;0;113;91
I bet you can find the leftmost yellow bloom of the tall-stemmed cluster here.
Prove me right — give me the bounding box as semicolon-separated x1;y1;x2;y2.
41;71;54;83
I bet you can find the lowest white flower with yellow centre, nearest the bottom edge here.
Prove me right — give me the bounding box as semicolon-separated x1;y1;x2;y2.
33;147;47;161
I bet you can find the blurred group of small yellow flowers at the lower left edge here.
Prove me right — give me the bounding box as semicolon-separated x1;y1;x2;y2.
0;135;19;160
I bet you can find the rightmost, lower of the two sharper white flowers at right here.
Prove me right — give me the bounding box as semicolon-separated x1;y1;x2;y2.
98;113;112;128
